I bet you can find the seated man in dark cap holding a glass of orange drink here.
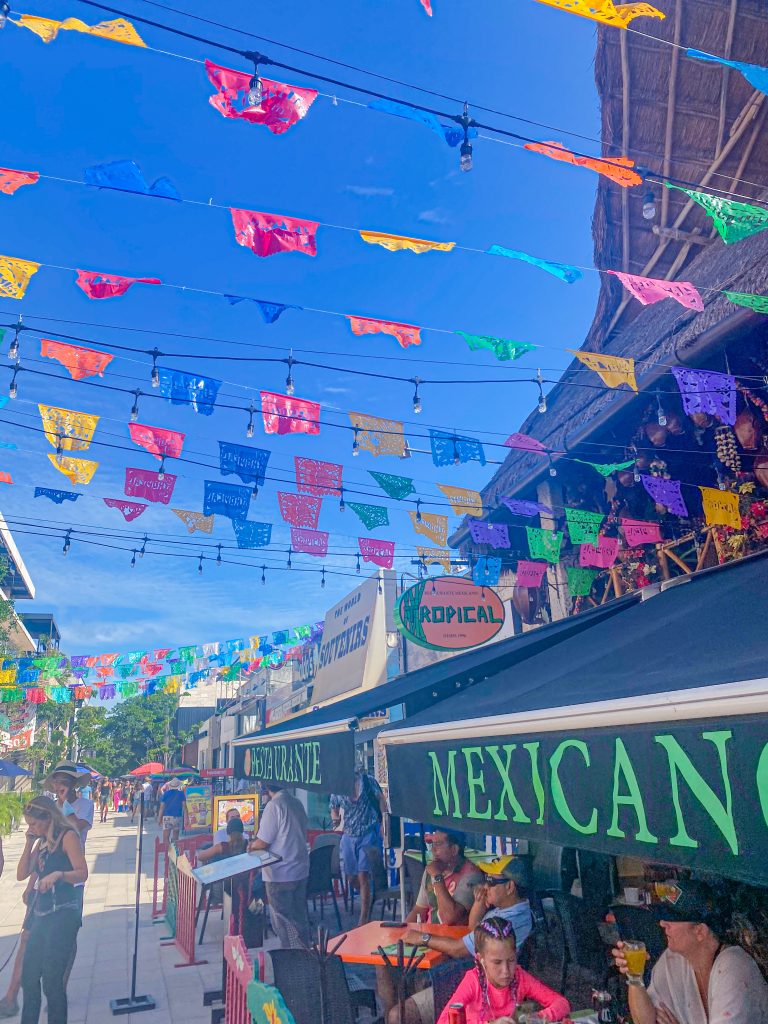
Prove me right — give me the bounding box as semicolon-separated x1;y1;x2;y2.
613;880;768;1024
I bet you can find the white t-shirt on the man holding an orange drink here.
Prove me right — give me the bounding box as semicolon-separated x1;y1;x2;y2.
648;946;768;1024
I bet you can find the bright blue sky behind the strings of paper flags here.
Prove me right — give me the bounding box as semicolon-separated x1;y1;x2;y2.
0;0;599;653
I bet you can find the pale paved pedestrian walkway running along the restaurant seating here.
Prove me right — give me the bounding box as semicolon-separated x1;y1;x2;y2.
0;814;224;1024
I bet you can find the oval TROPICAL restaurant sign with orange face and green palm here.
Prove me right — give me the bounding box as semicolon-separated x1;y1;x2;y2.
395;577;504;650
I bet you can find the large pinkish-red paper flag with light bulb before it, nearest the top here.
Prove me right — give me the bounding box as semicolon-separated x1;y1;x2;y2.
206;60;317;135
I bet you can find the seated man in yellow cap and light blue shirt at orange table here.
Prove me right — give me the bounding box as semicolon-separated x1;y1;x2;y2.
395;855;534;1024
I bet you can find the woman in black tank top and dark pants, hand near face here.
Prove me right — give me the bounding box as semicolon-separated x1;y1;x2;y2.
16;797;88;1024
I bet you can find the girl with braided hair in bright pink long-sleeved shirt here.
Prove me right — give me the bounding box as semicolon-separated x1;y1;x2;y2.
437;918;570;1024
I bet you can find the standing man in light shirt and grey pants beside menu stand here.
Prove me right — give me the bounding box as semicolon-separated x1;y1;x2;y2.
247;782;310;949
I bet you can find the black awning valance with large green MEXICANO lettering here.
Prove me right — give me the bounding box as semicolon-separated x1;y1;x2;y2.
387;716;768;885
